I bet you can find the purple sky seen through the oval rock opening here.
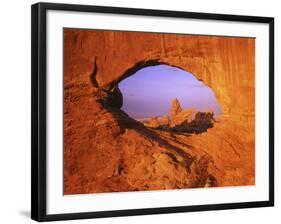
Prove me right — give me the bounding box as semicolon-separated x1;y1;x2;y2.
119;65;221;118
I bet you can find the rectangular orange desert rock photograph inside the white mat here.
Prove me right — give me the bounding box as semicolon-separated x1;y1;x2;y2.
62;27;256;195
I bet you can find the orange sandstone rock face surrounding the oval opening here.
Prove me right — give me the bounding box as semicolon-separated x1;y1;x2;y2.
64;29;255;194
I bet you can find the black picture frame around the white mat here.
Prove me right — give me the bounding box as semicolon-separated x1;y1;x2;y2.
31;3;274;221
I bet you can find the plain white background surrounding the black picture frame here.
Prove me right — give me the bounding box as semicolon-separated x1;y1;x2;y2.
0;0;276;224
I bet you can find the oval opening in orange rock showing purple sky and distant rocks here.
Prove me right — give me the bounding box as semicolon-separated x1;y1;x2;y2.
119;64;221;133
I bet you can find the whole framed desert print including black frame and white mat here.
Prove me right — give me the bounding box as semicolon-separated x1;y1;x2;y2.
31;3;274;221
